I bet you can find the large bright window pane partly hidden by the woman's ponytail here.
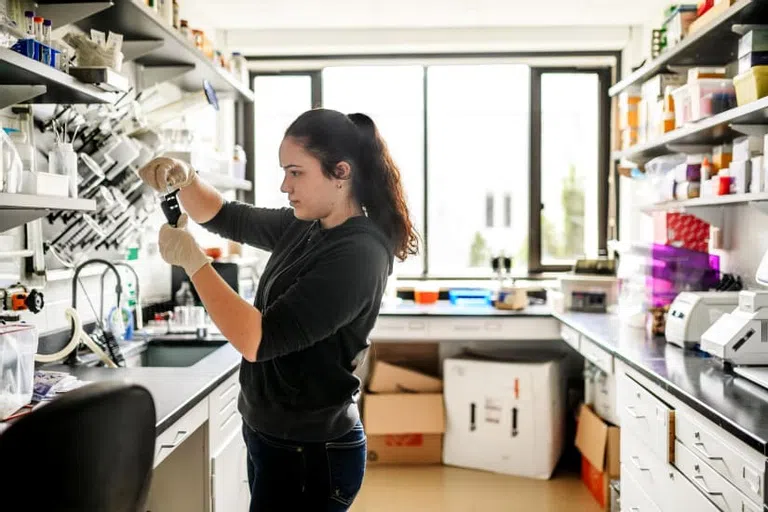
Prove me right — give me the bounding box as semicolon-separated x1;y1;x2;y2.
323;66;424;276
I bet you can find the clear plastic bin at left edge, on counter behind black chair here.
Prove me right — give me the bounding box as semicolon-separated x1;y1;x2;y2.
0;324;37;419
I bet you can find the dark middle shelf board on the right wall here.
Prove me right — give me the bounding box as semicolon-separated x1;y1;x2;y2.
613;97;768;164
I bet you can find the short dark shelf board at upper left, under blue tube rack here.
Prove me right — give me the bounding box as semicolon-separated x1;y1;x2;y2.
0;48;116;109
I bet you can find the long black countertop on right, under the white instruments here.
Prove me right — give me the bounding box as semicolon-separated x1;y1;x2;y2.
554;312;768;455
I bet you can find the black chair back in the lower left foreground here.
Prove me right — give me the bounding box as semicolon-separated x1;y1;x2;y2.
0;382;155;512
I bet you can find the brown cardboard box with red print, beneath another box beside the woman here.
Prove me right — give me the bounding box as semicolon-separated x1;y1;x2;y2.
363;393;445;464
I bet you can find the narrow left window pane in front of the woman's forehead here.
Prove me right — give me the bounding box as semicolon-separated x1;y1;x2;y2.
253;75;312;208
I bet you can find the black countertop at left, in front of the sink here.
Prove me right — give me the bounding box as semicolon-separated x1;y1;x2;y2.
45;344;242;435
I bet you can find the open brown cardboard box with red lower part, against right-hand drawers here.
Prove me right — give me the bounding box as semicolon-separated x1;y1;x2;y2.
576;405;620;510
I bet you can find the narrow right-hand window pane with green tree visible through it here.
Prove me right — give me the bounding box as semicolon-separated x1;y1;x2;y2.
541;73;600;265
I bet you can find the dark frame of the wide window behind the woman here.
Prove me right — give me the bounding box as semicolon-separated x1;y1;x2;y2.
248;51;621;280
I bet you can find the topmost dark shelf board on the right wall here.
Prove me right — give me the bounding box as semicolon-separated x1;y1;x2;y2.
608;0;768;96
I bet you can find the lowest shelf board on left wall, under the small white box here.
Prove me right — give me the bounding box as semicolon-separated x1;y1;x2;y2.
0;193;96;233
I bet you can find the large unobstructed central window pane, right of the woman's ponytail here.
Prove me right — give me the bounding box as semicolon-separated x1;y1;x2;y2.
427;65;530;276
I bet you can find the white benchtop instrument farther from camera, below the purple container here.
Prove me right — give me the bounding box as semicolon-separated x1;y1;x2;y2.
664;292;739;348
